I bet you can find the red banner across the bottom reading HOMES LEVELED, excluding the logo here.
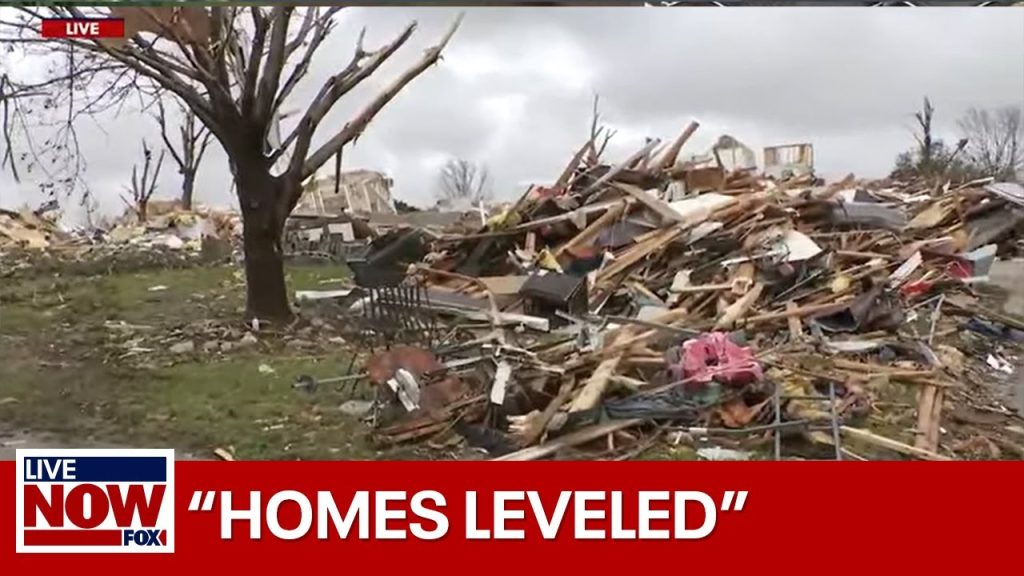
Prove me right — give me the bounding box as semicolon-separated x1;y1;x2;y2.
0;462;1024;575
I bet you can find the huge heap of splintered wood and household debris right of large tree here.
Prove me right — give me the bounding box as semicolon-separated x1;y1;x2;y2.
325;123;1024;459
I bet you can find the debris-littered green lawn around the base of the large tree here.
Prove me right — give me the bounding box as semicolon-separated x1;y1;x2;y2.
0;258;395;459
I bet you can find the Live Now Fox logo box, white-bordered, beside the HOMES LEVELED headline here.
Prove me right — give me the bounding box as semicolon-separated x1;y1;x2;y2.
15;450;174;552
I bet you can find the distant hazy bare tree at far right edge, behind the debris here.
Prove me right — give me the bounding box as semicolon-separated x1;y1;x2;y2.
957;106;1024;179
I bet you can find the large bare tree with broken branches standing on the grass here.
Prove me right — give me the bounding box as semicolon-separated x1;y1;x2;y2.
0;3;462;320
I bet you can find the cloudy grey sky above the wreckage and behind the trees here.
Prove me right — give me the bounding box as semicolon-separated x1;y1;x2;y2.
0;7;1024;219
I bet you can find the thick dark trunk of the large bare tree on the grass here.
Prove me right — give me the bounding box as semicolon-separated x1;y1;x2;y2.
236;164;292;322
